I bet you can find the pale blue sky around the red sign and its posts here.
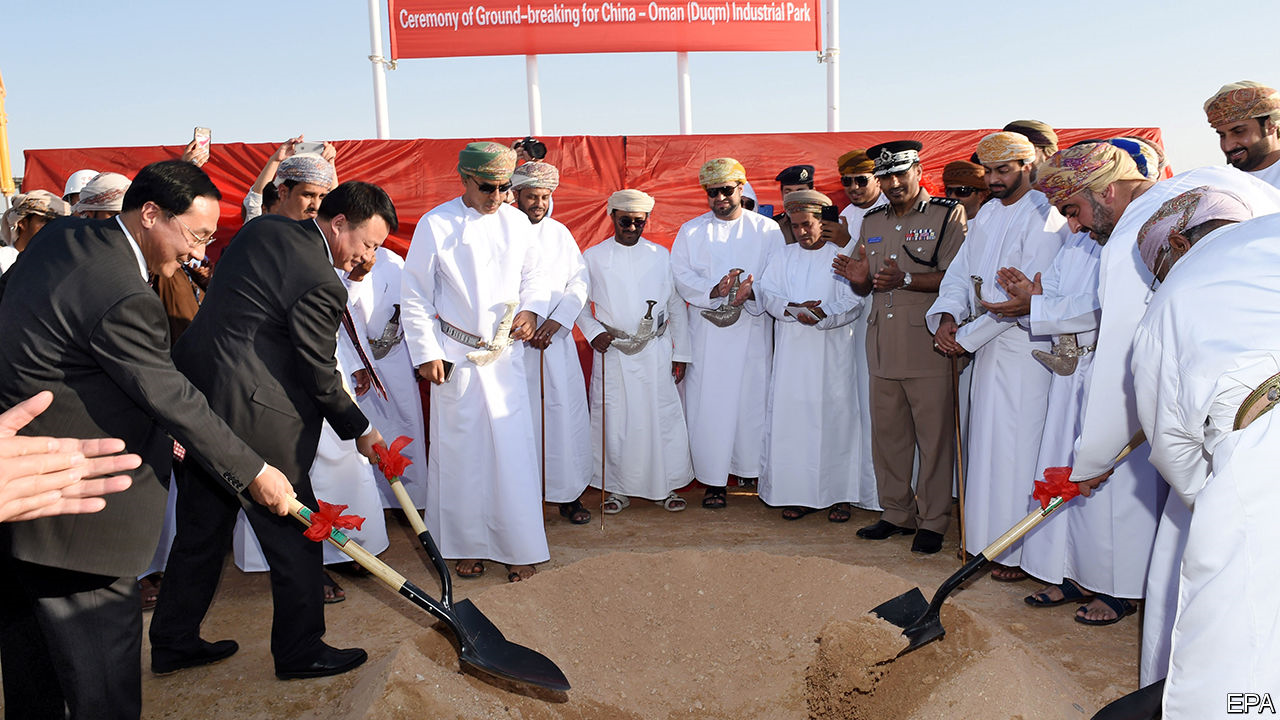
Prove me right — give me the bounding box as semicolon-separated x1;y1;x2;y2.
0;0;1280;174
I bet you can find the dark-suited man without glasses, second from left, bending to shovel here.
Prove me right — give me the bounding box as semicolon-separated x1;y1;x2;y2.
151;182;397;679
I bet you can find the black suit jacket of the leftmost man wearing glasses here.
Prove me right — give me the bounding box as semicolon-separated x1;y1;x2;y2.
0;218;262;577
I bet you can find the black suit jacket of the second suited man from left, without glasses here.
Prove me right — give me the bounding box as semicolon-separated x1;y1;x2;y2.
173;215;369;484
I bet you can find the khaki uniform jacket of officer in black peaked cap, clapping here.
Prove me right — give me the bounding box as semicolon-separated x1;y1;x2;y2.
854;188;965;379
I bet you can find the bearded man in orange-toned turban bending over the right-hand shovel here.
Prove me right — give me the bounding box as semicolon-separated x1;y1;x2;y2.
1036;142;1280;685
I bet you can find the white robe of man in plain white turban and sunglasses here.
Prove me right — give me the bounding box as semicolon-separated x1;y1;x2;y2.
577;238;694;500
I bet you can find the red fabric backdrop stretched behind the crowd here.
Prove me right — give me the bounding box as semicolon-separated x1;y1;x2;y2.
23;128;1161;254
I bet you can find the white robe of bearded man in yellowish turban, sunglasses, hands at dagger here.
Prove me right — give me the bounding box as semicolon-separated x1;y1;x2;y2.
671;211;786;487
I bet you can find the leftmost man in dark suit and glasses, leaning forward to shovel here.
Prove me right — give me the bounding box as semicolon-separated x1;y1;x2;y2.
0;160;293;719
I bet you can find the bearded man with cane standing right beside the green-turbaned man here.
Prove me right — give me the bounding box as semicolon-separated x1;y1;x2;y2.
511;160;593;525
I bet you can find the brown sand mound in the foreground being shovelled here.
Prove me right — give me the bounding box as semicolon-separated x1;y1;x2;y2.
338;551;1087;720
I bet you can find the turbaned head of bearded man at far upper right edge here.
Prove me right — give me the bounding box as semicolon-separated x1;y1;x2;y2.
1204;79;1280;187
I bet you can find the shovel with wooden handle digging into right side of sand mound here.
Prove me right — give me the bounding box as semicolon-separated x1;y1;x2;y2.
872;430;1147;657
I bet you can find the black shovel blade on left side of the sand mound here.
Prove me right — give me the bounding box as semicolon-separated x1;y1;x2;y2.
452;600;570;692
